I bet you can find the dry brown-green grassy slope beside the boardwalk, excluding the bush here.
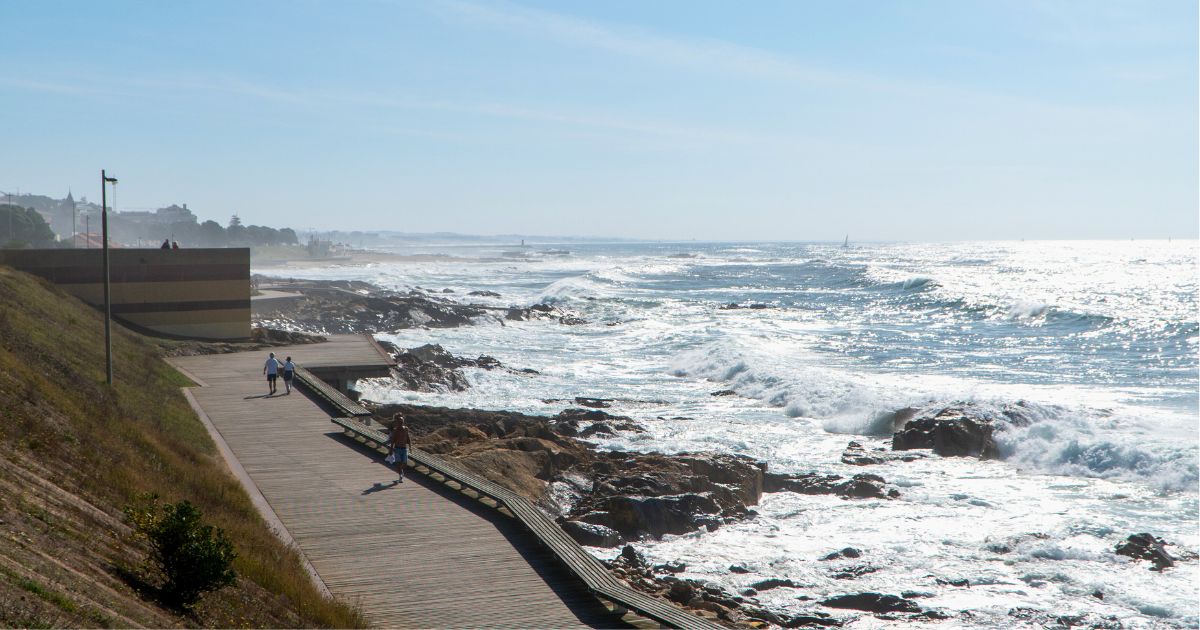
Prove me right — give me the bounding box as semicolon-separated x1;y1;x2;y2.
0;266;362;628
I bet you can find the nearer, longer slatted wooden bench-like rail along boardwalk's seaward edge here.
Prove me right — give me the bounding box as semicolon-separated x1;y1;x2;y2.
330;418;721;629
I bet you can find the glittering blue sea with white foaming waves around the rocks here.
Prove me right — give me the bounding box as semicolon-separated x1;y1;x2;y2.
263;241;1200;628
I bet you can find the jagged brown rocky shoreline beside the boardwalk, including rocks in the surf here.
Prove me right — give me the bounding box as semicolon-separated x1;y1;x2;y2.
248;281;1178;628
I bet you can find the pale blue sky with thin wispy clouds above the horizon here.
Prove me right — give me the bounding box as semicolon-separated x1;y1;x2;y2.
0;0;1200;241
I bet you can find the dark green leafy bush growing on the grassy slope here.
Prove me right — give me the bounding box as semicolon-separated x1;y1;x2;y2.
125;496;238;607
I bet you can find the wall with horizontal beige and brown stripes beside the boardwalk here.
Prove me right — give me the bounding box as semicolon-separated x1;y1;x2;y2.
0;247;250;340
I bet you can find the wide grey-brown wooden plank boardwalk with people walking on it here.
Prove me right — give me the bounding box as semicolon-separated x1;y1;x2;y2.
172;336;638;628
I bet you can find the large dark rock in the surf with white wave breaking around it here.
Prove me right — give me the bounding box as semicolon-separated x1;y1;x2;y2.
892;407;1000;460
